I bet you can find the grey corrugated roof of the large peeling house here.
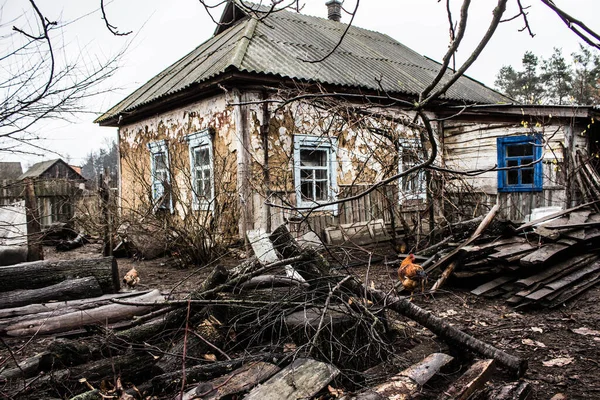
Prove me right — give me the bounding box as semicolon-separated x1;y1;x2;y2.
96;1;510;122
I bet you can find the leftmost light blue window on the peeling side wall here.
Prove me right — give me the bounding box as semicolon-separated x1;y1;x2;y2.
148;140;173;212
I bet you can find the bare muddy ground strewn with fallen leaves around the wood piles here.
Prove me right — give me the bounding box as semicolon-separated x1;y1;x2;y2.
8;243;600;399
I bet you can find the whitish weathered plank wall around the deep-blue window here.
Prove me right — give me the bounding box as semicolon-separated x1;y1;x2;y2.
443;122;584;221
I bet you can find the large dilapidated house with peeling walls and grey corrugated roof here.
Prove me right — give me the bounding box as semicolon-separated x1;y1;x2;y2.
95;0;598;242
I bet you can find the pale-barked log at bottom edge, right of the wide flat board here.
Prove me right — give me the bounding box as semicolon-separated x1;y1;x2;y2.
356;353;453;400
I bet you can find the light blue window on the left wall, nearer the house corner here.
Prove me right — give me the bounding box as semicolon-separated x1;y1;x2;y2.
185;129;215;210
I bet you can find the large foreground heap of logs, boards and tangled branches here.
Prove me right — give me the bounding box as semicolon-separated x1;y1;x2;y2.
0;227;527;399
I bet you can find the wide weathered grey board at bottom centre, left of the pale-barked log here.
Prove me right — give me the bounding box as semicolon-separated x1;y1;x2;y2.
244;358;340;400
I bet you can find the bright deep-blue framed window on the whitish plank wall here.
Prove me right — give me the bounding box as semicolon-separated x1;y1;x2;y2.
497;135;543;192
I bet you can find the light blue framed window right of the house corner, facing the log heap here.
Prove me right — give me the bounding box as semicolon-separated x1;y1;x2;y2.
294;135;338;215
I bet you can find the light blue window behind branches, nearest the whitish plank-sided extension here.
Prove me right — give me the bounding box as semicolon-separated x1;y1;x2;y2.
398;139;427;202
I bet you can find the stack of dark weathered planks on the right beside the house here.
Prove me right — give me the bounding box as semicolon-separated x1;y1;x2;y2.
440;204;600;308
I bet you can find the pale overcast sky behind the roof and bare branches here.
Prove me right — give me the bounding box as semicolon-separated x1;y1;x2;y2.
0;0;600;167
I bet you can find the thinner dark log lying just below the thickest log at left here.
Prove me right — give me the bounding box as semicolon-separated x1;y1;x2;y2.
0;276;102;308
